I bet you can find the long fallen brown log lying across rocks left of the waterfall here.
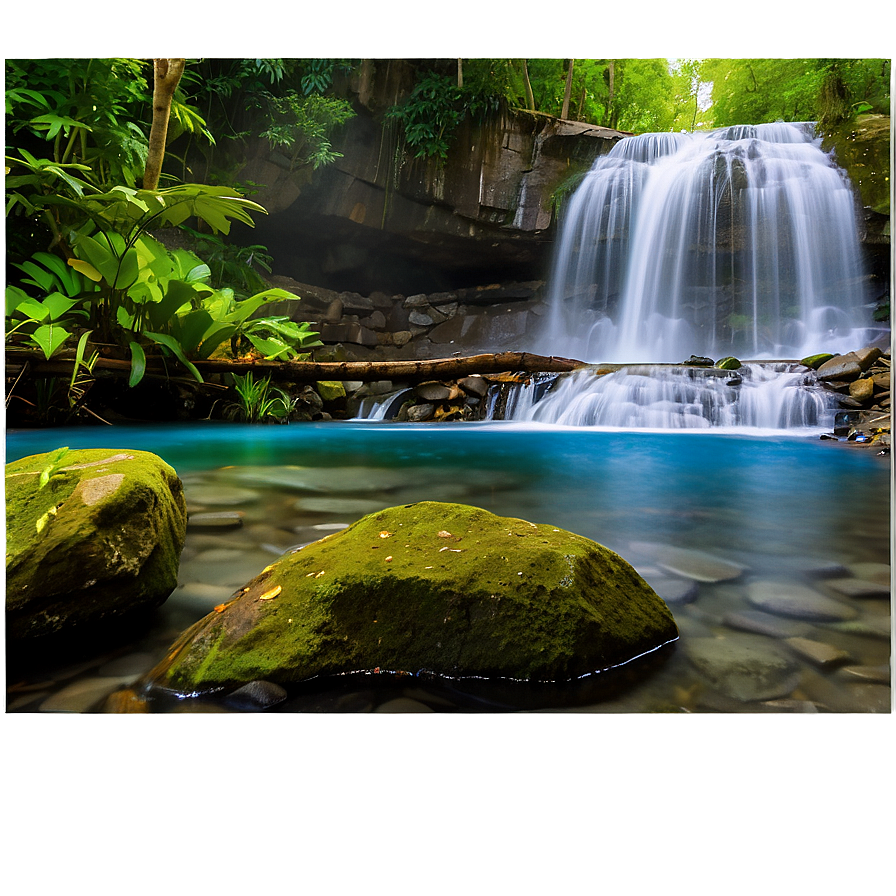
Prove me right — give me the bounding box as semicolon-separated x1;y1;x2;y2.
6;350;585;383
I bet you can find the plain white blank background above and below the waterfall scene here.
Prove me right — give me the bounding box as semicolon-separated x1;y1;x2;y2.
0;0;896;896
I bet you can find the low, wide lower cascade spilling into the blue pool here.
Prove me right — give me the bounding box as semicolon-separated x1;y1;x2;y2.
494;364;835;430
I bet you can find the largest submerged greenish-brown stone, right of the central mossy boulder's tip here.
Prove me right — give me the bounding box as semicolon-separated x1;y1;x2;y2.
684;638;800;702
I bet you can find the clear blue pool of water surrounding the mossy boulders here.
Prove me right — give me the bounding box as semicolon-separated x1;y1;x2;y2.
6;423;890;712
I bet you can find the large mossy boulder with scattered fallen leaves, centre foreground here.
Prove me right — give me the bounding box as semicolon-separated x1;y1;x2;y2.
143;502;678;708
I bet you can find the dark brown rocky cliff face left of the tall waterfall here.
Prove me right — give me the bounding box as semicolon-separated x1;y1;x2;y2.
238;60;625;293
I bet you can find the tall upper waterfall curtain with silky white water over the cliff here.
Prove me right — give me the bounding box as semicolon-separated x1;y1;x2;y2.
536;123;877;362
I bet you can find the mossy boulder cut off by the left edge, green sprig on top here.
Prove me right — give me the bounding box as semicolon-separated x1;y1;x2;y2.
5;449;187;655
